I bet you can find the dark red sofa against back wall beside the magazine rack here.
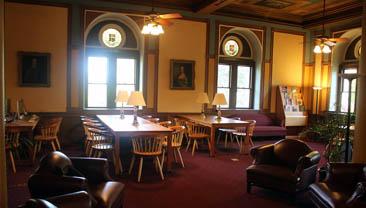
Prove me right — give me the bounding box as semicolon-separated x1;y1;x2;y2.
229;112;287;138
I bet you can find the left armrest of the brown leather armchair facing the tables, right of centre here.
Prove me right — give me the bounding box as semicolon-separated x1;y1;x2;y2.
250;144;274;164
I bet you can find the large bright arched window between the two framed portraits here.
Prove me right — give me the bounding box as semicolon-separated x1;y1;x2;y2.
85;19;141;108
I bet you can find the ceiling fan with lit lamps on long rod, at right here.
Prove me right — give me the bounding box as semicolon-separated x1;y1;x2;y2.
314;0;348;53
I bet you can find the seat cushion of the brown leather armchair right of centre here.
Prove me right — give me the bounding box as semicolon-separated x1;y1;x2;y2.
247;164;297;183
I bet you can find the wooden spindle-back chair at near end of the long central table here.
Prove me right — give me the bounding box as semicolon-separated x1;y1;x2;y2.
128;137;164;182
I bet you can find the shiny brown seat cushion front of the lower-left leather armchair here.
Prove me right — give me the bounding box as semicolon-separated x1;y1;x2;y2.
90;181;125;208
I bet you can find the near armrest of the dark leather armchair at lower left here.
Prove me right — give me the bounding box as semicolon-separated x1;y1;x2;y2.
28;174;88;199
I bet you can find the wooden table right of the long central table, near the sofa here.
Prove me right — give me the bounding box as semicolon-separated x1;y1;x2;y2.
179;114;249;157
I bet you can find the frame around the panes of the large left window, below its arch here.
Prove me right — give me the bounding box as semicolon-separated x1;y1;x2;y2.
83;47;141;109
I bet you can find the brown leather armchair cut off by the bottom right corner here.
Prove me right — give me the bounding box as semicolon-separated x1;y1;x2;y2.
308;163;366;208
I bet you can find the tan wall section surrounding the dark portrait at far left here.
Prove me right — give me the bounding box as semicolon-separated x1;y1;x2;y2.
5;2;68;112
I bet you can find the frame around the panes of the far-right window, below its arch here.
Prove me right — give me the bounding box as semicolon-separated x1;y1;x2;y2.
336;61;359;113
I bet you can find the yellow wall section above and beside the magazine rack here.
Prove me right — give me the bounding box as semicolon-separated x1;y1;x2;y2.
271;32;304;112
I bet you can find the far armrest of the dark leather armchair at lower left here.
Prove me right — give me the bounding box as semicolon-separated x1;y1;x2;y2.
70;157;112;183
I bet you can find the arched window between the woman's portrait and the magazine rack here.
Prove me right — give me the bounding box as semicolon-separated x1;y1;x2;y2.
216;33;255;109
